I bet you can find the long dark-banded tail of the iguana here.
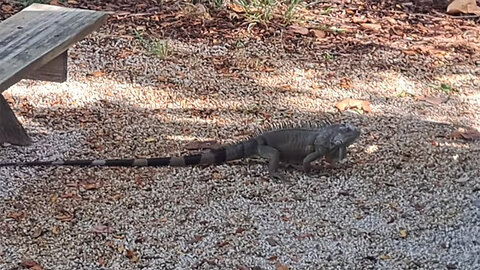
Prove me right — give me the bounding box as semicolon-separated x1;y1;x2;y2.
0;138;258;167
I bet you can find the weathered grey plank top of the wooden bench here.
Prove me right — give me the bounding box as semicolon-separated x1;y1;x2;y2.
0;4;108;93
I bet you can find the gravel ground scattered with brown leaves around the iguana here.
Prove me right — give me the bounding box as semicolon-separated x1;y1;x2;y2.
0;15;480;269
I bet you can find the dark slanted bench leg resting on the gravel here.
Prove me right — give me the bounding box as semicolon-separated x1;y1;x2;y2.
0;94;32;145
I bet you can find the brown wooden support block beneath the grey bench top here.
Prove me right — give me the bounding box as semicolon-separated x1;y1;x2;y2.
25;50;68;82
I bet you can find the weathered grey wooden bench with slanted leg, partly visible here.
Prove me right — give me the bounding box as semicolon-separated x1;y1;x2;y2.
0;4;108;145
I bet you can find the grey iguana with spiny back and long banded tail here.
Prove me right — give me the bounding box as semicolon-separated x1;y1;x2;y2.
0;123;360;177
